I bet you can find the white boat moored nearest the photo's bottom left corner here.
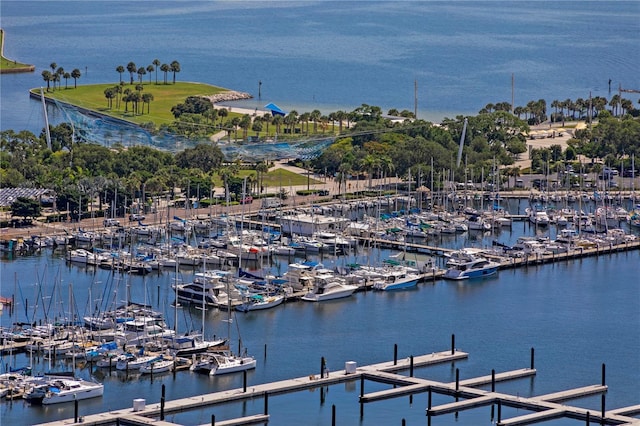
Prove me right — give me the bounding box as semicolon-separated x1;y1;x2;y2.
24;376;104;405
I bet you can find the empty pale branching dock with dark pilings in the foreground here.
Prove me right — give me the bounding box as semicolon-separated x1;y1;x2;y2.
36;344;640;426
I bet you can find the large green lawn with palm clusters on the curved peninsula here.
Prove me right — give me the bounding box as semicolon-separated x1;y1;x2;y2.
35;80;228;126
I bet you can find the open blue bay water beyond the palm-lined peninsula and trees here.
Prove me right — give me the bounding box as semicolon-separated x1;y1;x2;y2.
0;1;640;132
